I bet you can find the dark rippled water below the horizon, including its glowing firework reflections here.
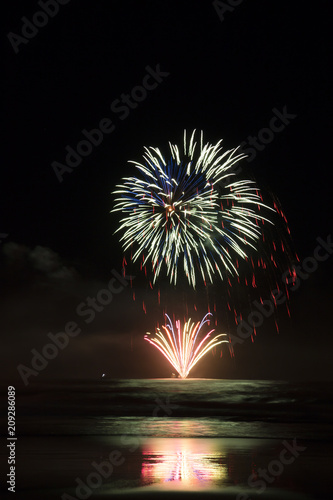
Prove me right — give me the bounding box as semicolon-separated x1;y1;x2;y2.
0;378;333;500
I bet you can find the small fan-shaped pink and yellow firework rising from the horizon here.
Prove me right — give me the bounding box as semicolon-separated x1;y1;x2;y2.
145;313;229;378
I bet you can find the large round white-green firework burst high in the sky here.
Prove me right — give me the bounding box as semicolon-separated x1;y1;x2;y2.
112;131;274;288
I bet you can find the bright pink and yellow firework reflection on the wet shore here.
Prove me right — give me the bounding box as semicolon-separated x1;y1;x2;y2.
141;439;227;487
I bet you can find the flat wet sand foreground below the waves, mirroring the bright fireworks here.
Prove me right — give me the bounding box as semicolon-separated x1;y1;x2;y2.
2;436;332;500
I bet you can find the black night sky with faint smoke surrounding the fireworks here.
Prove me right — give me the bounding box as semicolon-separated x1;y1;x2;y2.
0;0;333;382
